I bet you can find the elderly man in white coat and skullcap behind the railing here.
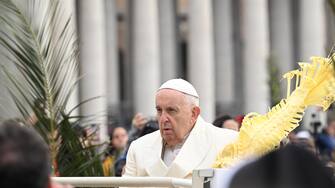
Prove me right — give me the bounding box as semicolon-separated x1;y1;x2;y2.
123;79;237;178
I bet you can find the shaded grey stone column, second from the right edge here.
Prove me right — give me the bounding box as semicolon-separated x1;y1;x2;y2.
269;0;295;97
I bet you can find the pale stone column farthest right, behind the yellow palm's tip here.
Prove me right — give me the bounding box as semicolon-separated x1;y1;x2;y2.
298;0;327;130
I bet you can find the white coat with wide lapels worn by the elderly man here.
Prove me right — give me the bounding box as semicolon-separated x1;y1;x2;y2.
123;116;237;179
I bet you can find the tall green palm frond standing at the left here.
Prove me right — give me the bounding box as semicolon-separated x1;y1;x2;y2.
0;0;103;176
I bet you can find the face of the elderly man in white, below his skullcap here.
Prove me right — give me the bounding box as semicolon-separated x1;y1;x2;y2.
156;89;200;146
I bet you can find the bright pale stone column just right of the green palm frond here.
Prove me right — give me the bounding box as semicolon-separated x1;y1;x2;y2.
77;0;108;142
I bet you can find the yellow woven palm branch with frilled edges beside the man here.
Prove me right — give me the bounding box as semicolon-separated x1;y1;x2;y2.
213;56;335;168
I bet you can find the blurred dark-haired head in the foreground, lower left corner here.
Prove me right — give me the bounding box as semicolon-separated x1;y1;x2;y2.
0;121;71;188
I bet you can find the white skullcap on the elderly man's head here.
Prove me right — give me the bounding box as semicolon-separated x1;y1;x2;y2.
157;78;199;98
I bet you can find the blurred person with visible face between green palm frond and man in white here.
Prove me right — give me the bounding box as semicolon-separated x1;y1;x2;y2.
103;127;128;176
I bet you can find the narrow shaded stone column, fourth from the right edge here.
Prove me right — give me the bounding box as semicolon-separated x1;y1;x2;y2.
213;0;236;114
